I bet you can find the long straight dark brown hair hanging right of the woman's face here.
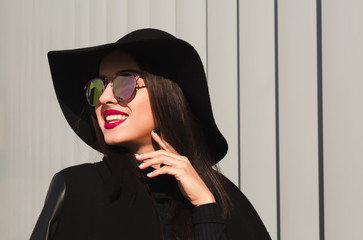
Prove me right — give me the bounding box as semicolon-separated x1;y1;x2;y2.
145;73;230;214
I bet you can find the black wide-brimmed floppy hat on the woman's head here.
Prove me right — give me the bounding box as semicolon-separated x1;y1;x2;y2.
48;29;228;161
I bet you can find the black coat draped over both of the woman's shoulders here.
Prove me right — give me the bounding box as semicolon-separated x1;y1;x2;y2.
30;161;270;240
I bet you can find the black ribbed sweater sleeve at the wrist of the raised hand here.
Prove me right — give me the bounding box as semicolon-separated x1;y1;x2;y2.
193;203;227;240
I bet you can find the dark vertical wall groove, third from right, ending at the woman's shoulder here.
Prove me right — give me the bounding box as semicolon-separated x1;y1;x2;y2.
236;0;241;189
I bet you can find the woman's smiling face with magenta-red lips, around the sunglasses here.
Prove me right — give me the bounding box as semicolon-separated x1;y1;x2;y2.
95;51;155;153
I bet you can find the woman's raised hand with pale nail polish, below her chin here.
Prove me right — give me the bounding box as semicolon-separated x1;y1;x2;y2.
136;132;215;206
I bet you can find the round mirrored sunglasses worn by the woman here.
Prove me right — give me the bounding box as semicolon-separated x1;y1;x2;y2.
84;72;145;106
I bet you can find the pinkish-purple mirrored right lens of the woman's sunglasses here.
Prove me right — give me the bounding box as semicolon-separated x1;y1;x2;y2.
113;75;136;101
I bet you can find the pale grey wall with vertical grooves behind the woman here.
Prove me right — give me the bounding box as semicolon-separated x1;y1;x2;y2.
0;0;363;240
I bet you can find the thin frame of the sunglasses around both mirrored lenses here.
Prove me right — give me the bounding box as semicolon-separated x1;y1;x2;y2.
84;71;146;107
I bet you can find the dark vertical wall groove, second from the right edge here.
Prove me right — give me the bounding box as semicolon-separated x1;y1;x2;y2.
274;0;281;240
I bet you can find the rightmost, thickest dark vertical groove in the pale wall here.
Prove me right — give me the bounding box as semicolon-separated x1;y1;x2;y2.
316;0;325;240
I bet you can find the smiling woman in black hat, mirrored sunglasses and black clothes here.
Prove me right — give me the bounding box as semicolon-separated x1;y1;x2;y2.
31;29;270;240
